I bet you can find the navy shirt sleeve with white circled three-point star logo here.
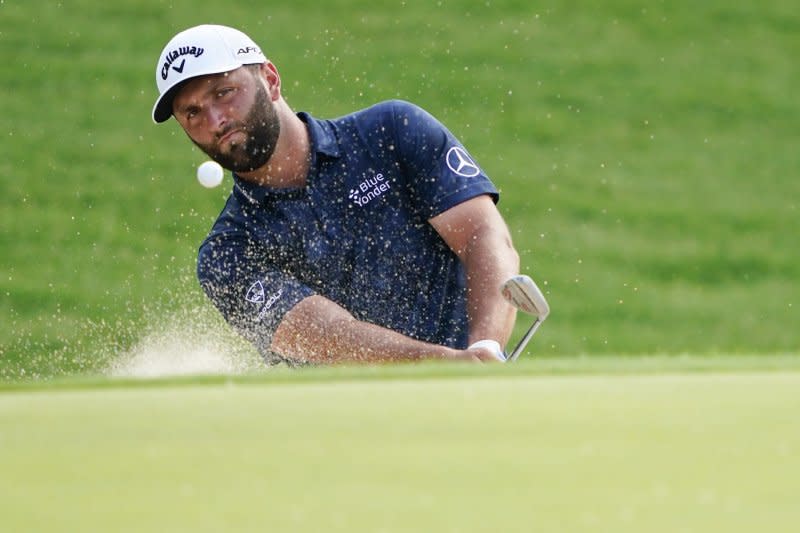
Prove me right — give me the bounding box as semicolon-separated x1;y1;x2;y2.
394;102;499;218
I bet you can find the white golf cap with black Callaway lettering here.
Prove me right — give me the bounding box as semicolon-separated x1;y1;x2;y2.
153;24;267;122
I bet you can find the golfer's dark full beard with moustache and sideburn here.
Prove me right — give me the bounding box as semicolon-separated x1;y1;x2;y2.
192;84;281;172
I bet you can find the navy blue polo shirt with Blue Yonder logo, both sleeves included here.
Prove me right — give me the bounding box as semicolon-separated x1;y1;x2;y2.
197;101;498;363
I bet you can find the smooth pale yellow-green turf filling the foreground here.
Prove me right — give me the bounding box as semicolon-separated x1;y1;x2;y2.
0;372;800;531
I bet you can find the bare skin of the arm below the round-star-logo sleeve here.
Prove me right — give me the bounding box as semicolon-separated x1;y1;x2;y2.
430;195;519;346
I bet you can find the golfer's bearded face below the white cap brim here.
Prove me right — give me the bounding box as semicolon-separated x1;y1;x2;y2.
173;67;280;172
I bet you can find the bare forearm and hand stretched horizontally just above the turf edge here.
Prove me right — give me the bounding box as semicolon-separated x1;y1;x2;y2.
271;295;504;364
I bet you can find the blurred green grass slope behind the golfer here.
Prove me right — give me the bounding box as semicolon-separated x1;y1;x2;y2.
0;0;800;380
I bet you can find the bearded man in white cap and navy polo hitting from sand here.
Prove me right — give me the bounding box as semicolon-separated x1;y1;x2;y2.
153;25;519;364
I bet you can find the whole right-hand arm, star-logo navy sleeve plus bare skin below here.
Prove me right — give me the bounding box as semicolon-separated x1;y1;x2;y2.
382;103;519;345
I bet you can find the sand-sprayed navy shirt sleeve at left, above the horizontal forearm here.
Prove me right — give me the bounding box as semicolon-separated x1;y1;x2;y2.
197;234;315;364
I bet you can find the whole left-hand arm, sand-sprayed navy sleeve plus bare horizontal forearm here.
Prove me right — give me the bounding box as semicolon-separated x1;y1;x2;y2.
198;233;506;363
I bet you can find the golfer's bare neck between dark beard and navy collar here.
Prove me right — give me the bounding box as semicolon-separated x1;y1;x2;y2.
236;108;311;189
